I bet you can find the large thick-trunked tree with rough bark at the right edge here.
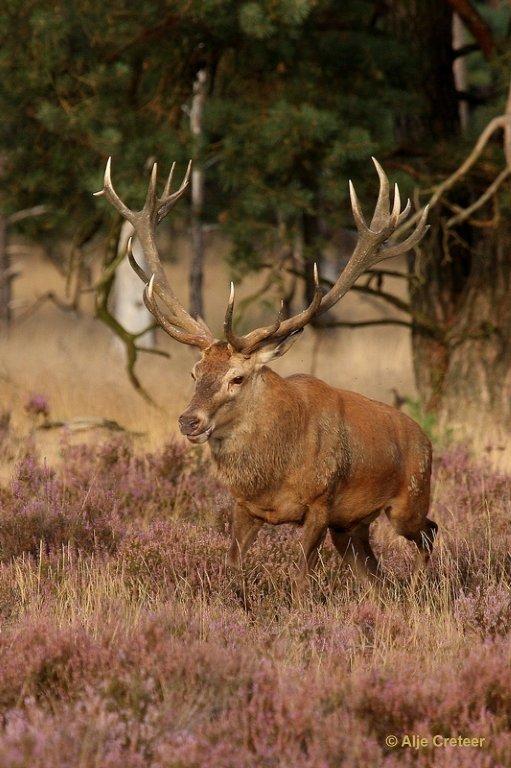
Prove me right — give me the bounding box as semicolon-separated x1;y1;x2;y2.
386;0;511;428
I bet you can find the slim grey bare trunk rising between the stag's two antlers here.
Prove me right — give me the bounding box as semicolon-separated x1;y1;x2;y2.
190;69;208;317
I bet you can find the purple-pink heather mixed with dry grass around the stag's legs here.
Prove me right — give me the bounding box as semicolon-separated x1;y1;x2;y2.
0;428;511;768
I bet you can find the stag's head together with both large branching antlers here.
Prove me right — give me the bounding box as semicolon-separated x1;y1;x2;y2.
95;158;427;443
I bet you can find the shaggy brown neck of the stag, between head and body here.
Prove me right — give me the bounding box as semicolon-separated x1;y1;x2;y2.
210;368;304;499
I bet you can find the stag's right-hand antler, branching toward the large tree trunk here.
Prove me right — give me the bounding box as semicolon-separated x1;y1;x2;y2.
224;162;428;351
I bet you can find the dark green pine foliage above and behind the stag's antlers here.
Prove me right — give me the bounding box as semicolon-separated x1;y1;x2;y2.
0;0;509;276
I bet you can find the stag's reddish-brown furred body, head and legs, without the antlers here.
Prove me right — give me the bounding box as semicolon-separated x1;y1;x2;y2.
180;339;436;576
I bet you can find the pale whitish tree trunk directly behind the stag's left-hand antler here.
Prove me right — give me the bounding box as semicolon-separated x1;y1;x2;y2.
112;221;154;350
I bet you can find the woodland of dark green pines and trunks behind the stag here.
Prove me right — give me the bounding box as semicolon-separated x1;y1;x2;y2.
0;0;511;444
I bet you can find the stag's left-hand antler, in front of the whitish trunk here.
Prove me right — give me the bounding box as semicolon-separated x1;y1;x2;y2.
94;157;215;349
